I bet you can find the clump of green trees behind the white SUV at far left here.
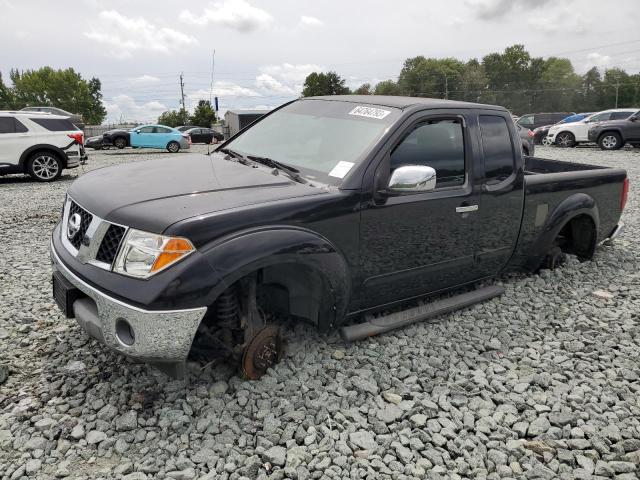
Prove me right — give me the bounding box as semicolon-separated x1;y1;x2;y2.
9;67;107;124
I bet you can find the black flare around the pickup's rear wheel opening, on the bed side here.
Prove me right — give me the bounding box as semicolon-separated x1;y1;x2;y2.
530;193;600;268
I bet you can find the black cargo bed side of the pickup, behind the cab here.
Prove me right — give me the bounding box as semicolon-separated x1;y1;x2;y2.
510;157;626;268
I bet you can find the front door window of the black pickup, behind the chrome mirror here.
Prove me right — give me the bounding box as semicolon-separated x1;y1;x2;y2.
391;119;465;188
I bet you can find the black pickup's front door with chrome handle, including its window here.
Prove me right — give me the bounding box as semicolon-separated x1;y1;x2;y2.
360;113;479;308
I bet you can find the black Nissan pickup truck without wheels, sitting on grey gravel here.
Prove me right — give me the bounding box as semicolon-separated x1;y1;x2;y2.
51;96;628;378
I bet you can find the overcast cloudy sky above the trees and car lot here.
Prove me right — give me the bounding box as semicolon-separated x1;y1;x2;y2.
0;0;640;121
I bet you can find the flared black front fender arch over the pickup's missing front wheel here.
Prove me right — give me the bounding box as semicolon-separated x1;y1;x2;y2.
201;226;351;327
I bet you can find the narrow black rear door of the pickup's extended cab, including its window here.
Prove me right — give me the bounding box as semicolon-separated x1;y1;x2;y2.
476;113;524;277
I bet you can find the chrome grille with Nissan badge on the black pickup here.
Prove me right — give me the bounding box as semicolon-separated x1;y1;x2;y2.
61;196;127;270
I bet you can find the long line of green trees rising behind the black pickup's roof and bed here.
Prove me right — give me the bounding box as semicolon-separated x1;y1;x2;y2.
302;45;640;115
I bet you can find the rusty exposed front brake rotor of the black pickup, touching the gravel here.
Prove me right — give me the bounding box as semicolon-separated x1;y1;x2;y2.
242;325;283;380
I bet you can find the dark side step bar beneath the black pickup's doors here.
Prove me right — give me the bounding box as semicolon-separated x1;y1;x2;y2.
340;285;504;342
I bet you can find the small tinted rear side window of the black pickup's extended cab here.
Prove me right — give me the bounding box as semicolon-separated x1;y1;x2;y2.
480;115;515;185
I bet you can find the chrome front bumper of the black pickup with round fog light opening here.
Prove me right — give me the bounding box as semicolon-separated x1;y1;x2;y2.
50;243;207;363
